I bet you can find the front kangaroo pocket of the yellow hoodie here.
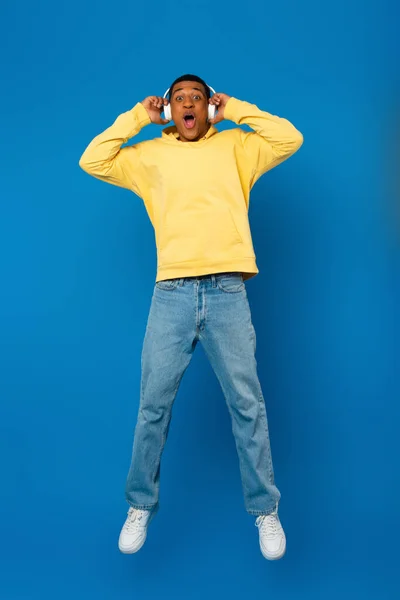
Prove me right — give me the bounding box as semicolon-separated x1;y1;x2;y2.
157;207;243;266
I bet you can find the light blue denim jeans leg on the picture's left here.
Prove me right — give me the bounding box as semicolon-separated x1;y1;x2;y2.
125;285;196;510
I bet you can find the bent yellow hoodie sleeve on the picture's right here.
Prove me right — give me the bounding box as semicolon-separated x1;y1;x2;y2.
224;98;303;185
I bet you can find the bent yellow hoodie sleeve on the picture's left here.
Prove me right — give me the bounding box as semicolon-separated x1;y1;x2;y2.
79;102;151;196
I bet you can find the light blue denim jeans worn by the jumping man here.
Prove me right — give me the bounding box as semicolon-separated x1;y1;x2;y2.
125;272;280;515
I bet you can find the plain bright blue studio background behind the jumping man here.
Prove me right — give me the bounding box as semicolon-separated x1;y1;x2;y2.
0;0;400;600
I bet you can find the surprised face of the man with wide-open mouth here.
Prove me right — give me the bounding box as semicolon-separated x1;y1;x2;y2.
170;81;209;142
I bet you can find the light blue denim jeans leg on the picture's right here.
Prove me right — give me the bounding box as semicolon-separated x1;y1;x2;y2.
200;276;281;515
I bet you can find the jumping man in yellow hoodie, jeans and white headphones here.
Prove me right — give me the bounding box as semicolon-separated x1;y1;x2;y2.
79;75;303;559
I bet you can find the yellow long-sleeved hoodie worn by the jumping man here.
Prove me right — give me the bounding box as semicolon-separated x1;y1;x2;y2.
79;98;303;281
